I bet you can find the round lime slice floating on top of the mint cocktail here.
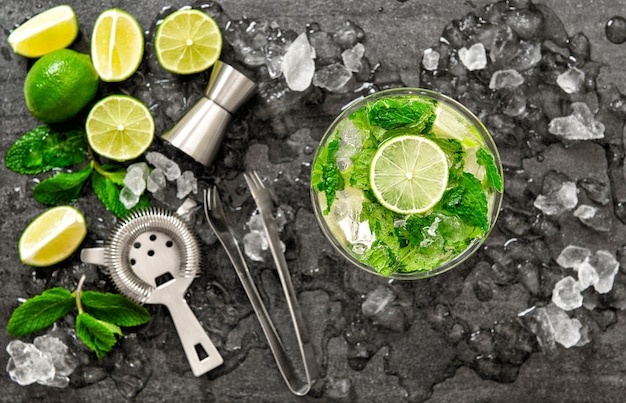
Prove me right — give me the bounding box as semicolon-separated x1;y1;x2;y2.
370;135;448;214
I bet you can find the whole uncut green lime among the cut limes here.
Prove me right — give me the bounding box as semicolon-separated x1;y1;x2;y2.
24;49;98;123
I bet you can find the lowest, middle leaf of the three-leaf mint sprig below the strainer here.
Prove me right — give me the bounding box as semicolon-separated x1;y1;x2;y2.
76;312;122;359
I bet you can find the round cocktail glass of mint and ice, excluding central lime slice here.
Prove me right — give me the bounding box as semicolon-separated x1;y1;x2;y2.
311;88;503;280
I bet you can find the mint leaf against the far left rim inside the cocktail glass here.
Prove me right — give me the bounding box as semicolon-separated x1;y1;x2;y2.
311;138;345;214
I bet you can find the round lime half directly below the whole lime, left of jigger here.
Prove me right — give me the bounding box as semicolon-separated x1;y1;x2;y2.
85;95;155;161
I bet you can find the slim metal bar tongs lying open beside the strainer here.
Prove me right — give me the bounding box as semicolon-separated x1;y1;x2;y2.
204;172;317;396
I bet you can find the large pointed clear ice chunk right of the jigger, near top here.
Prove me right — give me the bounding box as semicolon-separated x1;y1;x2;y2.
283;32;315;91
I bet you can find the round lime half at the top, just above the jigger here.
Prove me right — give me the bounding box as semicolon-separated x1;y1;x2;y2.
154;9;222;74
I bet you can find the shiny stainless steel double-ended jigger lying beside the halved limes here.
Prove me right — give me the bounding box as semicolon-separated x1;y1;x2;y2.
162;60;256;167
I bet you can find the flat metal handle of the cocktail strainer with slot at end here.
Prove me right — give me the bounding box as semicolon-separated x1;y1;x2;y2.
163;296;224;376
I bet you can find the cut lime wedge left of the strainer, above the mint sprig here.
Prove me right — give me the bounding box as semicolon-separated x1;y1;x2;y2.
18;206;87;267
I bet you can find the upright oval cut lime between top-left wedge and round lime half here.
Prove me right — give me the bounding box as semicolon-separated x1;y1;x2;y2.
91;8;143;82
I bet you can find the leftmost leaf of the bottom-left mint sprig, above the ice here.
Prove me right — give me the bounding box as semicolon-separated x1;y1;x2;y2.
7;287;76;337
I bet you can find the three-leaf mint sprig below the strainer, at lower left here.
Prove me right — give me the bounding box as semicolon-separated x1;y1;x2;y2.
7;275;150;359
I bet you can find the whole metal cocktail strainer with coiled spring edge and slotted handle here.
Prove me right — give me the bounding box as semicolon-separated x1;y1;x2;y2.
80;204;224;376
